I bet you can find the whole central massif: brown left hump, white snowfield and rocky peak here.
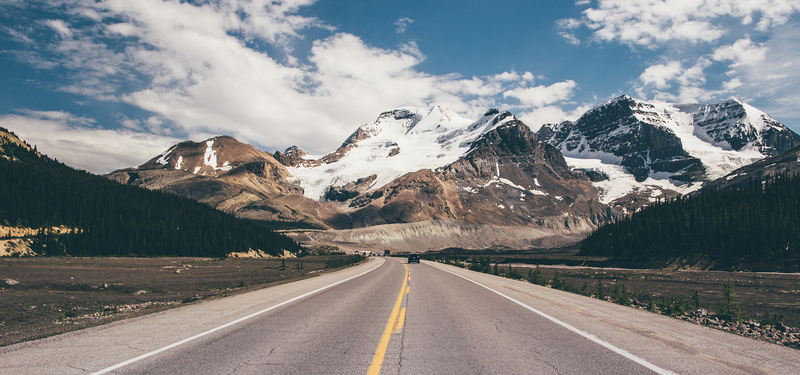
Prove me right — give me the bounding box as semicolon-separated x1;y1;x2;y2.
108;106;616;248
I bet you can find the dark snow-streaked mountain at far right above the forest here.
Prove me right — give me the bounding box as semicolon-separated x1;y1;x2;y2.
538;96;800;208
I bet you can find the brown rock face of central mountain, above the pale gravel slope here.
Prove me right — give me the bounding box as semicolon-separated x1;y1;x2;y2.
316;113;617;233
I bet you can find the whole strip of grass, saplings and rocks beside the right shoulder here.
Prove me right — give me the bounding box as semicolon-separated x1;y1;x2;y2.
423;254;800;349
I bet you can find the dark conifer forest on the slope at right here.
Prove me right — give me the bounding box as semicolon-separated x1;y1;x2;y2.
579;174;800;271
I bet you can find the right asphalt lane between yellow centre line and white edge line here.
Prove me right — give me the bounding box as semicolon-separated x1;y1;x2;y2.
384;264;649;374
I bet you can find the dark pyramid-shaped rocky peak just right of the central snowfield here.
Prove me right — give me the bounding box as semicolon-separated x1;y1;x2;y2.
443;120;614;225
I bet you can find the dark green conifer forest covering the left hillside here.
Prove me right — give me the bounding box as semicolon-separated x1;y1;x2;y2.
0;135;299;257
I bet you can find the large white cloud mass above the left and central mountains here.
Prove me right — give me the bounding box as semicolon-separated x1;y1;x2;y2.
3;0;588;171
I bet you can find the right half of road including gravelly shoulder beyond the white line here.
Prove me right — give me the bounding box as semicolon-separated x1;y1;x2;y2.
396;262;800;374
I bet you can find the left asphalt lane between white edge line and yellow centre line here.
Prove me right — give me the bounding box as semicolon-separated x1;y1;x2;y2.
113;261;405;374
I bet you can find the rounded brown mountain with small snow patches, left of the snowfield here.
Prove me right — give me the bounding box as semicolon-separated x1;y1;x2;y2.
106;137;327;227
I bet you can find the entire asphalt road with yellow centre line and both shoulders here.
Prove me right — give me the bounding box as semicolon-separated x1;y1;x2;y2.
0;258;800;374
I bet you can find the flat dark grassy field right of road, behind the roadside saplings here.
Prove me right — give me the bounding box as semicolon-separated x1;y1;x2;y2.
424;252;800;327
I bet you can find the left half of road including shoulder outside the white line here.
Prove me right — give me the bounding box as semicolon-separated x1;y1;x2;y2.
0;259;396;374
